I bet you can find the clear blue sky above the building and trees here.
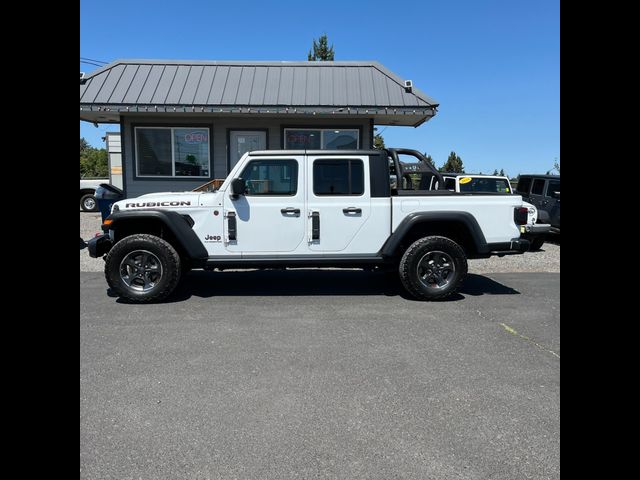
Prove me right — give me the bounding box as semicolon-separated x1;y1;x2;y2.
80;0;560;176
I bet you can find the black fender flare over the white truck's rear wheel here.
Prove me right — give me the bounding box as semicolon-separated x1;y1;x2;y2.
380;211;490;257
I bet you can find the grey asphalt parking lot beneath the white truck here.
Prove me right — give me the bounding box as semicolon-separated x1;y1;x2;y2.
80;268;560;480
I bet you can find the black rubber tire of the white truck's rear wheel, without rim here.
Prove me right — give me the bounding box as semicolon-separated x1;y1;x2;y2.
398;236;468;300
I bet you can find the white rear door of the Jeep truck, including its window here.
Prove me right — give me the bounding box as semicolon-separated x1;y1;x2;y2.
307;155;390;254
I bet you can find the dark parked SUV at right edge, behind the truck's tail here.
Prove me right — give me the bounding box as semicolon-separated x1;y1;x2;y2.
516;174;560;234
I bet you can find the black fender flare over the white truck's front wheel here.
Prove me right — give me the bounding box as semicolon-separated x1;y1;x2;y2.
105;210;209;260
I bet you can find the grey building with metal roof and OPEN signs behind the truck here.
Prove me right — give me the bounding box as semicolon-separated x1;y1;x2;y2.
80;60;438;197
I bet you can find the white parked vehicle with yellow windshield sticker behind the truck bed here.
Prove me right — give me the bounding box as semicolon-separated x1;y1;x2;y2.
442;173;551;251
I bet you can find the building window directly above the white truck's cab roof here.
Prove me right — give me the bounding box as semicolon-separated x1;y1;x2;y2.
284;128;360;150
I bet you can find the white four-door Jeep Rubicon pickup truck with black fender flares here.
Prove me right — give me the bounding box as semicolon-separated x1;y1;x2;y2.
88;148;529;302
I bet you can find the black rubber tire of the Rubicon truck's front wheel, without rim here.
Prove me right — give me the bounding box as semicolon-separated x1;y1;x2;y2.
104;234;182;303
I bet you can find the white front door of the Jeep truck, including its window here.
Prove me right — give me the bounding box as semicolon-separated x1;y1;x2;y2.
224;156;306;257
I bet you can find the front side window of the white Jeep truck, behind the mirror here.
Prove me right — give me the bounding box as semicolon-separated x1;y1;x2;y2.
240;159;298;196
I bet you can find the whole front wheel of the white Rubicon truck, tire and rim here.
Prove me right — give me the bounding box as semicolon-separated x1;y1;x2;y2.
104;234;182;303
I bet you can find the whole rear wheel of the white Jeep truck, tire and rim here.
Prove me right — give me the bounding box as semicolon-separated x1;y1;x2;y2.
398;236;468;300
